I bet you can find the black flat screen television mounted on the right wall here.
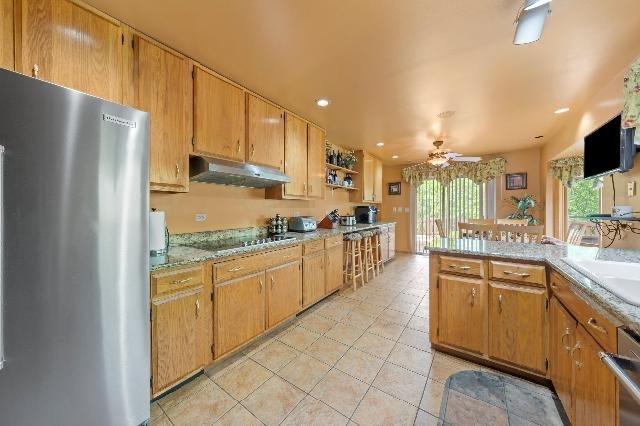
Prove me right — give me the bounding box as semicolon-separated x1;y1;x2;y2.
584;115;636;179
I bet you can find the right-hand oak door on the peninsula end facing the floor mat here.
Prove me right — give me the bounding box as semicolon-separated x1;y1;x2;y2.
489;282;547;374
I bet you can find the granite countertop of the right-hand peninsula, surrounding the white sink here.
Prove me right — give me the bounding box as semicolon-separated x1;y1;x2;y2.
426;238;640;333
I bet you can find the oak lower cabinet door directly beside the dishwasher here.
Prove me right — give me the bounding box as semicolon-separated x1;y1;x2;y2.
573;325;617;425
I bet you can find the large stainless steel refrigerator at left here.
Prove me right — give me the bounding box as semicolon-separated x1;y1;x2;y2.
0;70;150;426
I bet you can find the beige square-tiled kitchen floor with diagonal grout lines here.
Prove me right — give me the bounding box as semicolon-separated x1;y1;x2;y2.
151;255;556;425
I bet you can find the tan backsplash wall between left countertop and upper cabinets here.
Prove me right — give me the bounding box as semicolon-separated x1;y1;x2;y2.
151;182;358;234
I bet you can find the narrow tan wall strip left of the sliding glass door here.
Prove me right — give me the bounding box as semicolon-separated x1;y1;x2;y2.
380;166;413;252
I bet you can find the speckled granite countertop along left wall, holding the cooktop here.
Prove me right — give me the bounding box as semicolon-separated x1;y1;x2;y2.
150;222;395;272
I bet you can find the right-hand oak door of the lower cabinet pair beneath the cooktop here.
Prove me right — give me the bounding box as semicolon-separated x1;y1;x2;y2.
266;261;302;328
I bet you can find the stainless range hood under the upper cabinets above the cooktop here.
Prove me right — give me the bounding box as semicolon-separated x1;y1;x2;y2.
189;157;291;188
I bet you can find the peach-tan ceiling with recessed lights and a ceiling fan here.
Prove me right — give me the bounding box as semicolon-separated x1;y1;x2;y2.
88;0;640;164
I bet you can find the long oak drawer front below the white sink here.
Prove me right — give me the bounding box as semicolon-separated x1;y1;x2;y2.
551;272;618;353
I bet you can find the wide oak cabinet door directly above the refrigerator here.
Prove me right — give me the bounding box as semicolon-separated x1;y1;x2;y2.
16;0;123;102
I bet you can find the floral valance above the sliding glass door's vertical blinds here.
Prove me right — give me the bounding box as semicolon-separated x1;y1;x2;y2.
402;157;507;185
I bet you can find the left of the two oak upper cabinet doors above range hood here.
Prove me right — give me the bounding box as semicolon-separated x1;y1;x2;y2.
193;67;245;161
